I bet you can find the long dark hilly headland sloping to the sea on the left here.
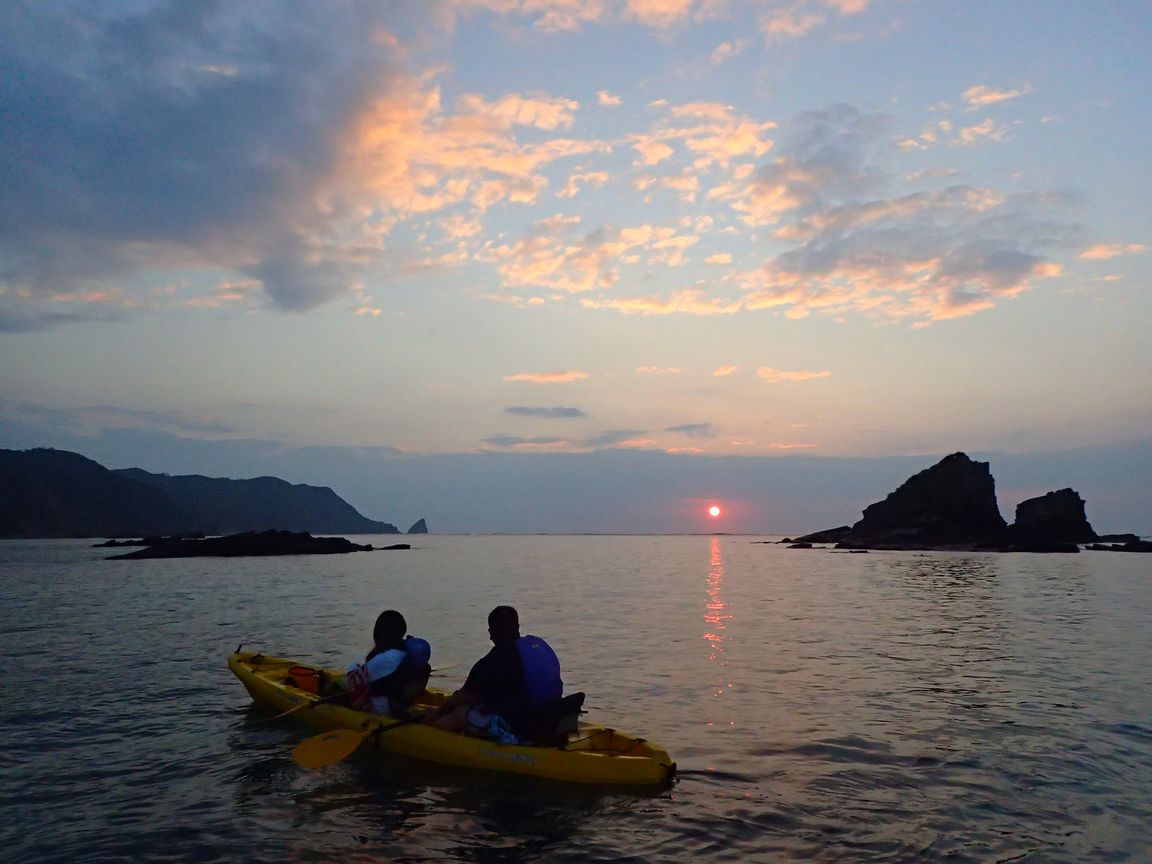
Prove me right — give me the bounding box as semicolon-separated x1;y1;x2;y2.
0;448;426;538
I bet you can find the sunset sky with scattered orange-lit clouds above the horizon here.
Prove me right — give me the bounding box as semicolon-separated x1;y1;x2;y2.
0;0;1152;532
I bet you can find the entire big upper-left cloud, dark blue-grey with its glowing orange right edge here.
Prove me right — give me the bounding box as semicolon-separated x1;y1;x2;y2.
0;0;607;329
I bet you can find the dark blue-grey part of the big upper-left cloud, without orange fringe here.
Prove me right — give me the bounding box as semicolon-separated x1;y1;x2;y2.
0;2;423;321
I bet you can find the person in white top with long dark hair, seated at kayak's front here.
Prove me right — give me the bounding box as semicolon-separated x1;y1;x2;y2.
348;609;432;714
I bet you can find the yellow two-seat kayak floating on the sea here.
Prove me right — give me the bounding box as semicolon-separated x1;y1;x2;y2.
228;651;676;786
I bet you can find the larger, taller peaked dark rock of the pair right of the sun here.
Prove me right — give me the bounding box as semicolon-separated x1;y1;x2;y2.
836;453;1007;550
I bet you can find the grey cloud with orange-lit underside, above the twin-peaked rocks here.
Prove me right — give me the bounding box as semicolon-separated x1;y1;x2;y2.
718;106;1079;326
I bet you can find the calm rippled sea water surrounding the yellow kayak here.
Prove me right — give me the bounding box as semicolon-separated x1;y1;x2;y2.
0;536;1152;864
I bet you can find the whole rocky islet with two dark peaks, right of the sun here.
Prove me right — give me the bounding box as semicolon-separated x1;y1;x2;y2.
781;453;1152;552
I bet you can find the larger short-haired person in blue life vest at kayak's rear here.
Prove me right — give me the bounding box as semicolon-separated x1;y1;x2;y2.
424;606;563;743
